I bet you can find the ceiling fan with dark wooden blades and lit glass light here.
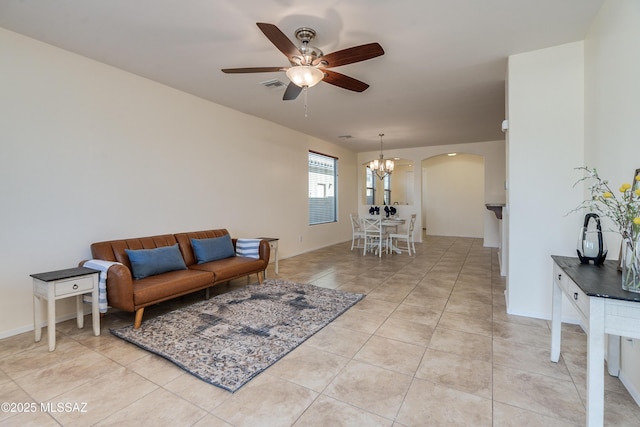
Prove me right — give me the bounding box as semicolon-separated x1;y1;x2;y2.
222;22;384;101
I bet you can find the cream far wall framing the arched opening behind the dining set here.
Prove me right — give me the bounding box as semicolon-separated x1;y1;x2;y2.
357;140;505;247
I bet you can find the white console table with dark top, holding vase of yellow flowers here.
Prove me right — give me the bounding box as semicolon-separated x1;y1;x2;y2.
551;255;640;427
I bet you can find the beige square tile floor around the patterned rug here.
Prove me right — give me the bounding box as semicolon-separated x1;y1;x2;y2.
0;237;640;427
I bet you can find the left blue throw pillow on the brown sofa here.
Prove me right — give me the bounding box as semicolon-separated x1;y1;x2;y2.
125;243;187;280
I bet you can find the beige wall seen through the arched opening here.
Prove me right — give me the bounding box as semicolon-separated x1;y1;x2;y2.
422;154;484;238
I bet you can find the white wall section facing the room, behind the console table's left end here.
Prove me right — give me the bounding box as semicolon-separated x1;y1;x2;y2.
507;42;584;319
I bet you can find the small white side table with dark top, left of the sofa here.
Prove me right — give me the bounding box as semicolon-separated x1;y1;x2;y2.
31;267;100;351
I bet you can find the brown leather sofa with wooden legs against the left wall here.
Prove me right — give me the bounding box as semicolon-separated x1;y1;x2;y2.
91;229;270;329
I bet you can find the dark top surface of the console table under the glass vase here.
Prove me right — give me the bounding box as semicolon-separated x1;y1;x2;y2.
551;255;640;302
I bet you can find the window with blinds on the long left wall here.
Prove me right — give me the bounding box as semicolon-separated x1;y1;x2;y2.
309;151;338;225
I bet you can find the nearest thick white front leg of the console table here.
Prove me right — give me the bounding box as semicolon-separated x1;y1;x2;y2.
587;298;605;427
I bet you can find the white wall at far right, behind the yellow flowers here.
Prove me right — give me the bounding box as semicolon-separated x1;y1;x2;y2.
585;0;640;401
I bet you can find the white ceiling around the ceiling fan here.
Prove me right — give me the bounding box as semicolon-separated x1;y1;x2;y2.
0;0;603;151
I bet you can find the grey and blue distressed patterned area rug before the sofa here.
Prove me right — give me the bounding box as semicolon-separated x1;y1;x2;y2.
111;279;364;392
